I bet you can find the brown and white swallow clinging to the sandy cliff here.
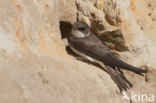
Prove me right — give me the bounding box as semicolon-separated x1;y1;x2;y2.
68;21;147;91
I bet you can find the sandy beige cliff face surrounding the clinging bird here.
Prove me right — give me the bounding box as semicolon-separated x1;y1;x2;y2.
0;0;156;103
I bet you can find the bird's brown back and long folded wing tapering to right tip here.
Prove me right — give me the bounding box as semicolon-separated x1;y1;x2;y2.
68;34;147;74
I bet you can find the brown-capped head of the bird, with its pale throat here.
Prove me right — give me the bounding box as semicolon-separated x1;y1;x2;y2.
71;21;90;38
